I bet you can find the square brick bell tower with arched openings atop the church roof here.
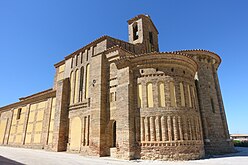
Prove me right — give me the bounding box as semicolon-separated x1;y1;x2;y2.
128;14;159;53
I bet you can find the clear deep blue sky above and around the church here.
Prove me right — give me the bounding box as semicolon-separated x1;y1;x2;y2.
0;0;248;133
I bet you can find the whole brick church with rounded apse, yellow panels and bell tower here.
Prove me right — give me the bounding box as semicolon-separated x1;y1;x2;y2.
0;15;233;160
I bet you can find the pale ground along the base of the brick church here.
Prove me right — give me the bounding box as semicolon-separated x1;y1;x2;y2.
0;146;248;165
